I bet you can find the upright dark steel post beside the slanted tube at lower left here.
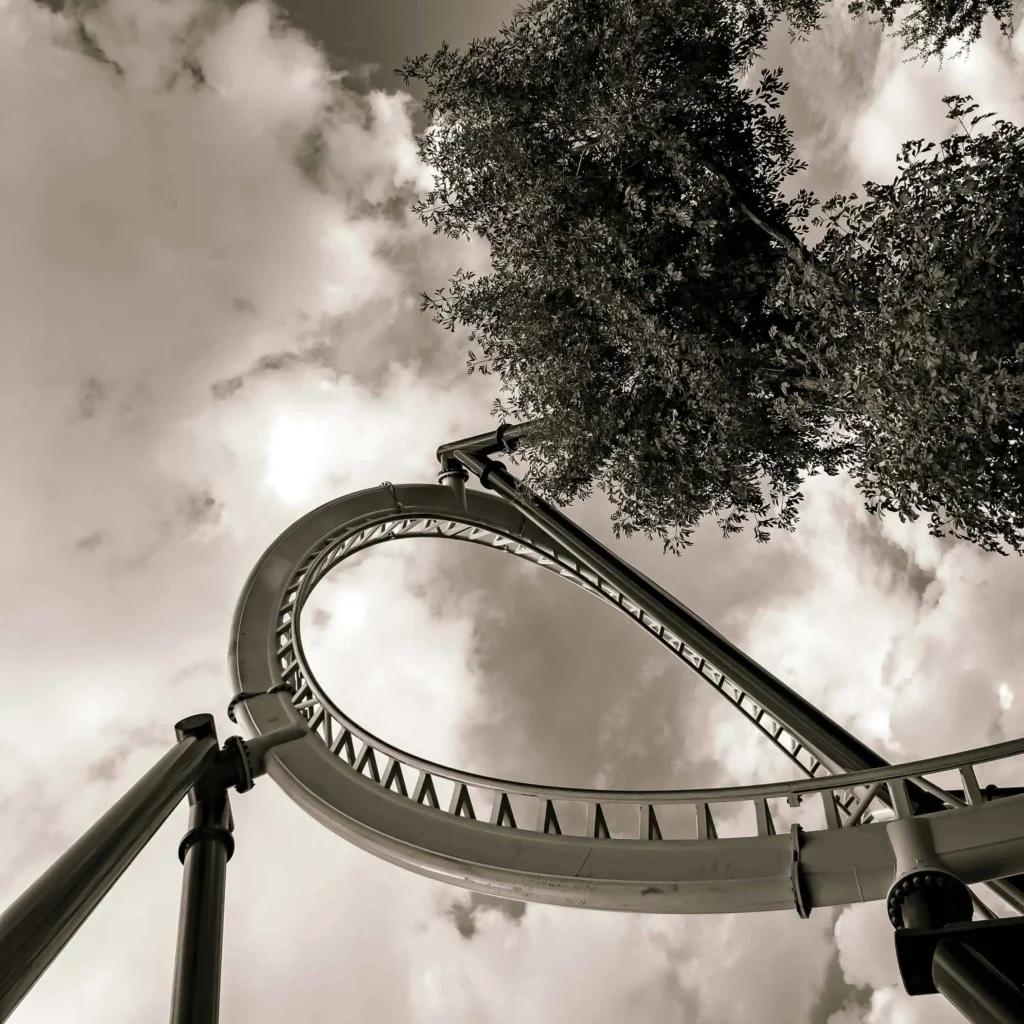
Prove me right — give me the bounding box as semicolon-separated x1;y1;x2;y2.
171;715;234;1024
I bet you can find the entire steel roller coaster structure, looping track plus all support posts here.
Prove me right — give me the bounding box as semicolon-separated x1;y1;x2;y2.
0;424;1024;1024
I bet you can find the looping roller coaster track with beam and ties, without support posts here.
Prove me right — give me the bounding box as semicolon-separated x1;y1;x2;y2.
230;484;1024;913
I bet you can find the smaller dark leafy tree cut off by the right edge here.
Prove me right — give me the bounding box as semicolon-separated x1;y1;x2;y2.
779;96;1024;553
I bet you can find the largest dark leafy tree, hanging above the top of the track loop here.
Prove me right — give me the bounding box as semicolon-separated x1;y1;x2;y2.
402;0;856;550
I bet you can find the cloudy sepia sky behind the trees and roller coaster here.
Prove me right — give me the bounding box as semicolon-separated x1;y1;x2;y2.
0;0;1024;1024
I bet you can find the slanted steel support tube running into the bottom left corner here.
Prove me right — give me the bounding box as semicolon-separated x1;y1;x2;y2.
0;736;217;1021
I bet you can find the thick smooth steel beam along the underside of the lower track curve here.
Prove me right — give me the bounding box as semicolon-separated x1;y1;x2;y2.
228;691;1024;915
